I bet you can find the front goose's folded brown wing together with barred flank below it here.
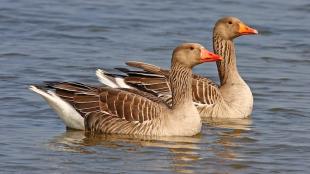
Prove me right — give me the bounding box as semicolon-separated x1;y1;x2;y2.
48;82;166;135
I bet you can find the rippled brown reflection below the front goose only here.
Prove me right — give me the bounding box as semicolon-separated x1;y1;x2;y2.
48;130;201;173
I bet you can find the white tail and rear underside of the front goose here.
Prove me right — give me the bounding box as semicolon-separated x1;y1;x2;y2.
29;85;85;130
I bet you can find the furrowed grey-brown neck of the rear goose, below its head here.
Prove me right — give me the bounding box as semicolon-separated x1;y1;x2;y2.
213;33;241;86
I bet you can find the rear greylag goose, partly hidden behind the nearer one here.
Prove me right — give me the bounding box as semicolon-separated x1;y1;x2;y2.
96;17;258;118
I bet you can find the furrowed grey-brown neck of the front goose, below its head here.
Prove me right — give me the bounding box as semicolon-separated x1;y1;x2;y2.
169;62;192;109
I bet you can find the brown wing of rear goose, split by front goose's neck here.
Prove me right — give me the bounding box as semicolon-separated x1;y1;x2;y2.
120;61;221;105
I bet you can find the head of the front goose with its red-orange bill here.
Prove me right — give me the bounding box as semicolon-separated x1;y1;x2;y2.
172;43;223;68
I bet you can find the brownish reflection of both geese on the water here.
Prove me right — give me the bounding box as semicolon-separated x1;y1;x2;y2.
48;119;252;173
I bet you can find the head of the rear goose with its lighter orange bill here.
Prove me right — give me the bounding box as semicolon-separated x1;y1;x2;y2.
213;16;258;40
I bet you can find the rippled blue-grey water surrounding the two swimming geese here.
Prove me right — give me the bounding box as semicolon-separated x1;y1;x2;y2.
0;0;310;173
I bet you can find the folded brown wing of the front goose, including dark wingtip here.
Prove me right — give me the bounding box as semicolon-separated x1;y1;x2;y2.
48;83;161;125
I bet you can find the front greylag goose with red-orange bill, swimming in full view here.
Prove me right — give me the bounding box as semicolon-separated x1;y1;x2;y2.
30;43;222;136
